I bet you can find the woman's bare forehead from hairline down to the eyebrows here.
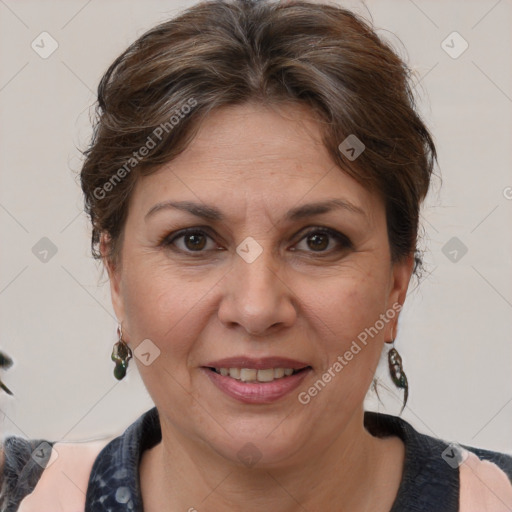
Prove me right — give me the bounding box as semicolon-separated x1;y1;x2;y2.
132;104;378;226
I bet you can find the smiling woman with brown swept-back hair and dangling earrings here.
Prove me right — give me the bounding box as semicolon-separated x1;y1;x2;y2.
2;0;512;512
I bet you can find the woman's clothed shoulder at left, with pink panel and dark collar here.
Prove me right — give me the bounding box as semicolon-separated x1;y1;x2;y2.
0;407;161;512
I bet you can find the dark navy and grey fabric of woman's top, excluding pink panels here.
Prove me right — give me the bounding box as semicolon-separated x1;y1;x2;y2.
0;407;512;512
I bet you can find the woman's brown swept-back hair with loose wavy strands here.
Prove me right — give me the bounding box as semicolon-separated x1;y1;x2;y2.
81;0;436;272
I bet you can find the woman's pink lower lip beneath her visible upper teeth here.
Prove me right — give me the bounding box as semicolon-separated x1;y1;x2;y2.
202;368;311;404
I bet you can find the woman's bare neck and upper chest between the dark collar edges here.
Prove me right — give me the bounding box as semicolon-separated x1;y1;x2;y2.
140;410;404;512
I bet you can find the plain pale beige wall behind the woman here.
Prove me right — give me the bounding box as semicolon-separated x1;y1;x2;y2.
0;0;512;453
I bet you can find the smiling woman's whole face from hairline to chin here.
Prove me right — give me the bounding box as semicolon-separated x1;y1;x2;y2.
104;104;412;465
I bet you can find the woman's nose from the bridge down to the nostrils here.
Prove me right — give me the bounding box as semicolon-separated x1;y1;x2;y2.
218;249;297;336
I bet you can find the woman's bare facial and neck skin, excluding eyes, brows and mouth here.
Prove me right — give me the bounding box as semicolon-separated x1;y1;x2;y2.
101;104;413;512
